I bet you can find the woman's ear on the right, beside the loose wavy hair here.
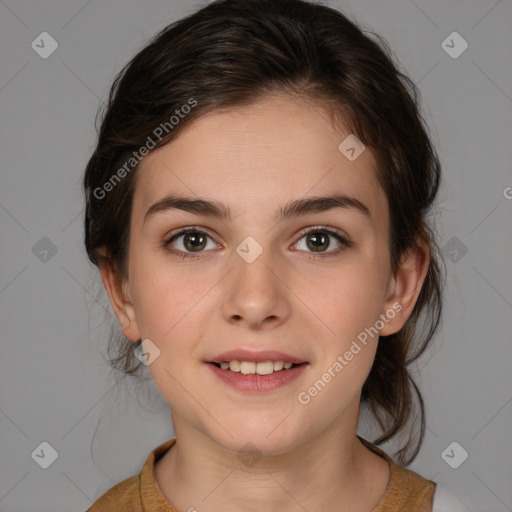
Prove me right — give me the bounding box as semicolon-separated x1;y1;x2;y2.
379;241;430;336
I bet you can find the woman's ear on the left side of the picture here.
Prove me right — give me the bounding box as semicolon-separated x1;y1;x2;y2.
100;254;141;341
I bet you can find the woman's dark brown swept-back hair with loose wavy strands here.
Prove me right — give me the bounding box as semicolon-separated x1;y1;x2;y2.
83;0;444;464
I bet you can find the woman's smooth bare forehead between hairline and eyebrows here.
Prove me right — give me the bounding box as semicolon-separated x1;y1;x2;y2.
134;95;386;224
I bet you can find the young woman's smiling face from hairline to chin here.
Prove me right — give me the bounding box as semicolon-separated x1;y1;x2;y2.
102;95;422;453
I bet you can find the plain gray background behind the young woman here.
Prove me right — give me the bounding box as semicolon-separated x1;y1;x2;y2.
0;0;512;512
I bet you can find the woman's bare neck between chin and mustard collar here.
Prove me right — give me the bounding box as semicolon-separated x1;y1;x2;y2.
155;416;389;512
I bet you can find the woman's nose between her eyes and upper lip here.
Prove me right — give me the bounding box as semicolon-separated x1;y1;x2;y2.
223;242;291;330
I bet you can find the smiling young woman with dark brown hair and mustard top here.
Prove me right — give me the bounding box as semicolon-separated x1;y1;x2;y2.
84;0;466;512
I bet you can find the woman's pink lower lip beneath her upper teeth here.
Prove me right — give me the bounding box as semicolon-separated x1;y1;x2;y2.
206;363;308;392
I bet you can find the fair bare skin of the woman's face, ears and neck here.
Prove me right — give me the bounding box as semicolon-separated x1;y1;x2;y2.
101;94;429;512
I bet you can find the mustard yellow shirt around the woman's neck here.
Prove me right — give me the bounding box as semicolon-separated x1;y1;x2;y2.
86;436;436;512
